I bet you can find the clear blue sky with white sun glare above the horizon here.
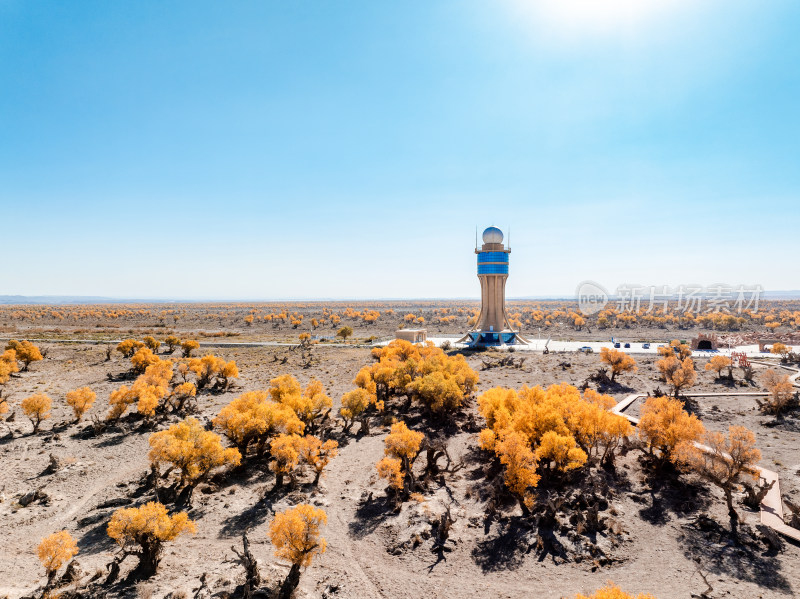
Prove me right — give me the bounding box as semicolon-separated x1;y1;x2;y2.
0;0;800;299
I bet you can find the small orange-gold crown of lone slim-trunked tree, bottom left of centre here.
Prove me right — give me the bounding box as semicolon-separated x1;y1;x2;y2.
269;503;328;567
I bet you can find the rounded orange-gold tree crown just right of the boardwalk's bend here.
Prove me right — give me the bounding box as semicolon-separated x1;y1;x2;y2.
639;396;705;462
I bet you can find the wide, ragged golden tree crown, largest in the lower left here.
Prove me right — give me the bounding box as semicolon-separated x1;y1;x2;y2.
148;417;242;487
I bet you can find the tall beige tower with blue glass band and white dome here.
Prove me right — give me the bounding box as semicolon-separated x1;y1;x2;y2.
461;227;528;347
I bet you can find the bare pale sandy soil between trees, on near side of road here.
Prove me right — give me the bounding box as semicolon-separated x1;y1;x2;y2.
0;344;800;599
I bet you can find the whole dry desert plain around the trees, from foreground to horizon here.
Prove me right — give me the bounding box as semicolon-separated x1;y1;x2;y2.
0;302;800;599
